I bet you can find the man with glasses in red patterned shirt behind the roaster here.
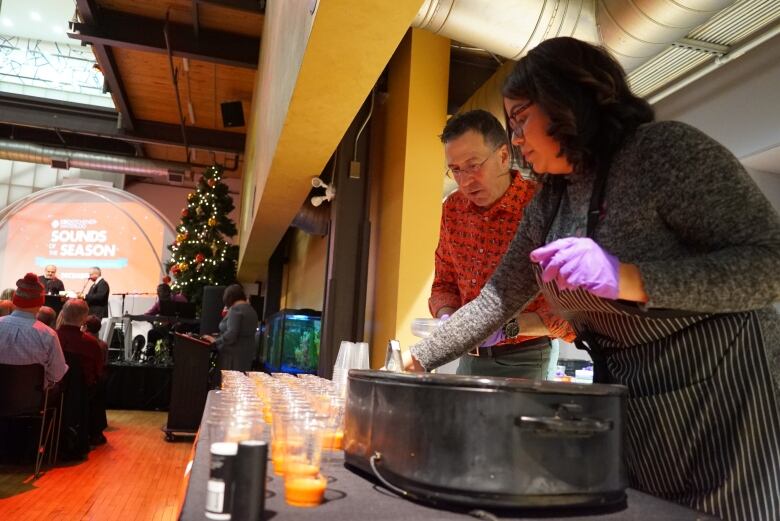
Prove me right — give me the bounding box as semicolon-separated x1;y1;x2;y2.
428;110;574;379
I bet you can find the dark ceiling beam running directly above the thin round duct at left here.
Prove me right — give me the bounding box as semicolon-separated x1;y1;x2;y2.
0;93;246;154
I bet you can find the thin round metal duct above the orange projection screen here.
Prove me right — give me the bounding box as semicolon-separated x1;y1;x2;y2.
0;139;191;182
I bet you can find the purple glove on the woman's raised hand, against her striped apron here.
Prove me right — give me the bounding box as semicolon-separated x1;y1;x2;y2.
530;237;620;300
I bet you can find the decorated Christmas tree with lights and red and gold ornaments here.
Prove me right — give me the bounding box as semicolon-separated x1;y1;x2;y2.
167;165;238;307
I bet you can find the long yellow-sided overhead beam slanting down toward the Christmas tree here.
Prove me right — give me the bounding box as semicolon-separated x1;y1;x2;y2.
238;0;422;281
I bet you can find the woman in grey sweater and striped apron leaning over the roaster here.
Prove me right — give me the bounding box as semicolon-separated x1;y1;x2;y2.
405;38;780;521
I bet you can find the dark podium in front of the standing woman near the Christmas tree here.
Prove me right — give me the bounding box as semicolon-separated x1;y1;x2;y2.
162;333;211;441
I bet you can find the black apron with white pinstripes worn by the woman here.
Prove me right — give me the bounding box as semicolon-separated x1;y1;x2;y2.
536;266;780;521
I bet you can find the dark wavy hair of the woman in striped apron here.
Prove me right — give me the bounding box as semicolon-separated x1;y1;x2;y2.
502;37;655;173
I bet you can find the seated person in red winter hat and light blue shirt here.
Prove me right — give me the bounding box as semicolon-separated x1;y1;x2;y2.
0;273;68;389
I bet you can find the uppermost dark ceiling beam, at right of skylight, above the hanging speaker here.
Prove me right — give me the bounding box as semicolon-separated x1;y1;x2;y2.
68;7;260;69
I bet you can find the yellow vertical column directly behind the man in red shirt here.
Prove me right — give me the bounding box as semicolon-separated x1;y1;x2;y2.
366;29;450;367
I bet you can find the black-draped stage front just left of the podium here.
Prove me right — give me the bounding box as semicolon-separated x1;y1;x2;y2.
106;362;173;411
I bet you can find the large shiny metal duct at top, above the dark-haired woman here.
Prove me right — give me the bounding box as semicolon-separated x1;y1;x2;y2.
412;0;733;72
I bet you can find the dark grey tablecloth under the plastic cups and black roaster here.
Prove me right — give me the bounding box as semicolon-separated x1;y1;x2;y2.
179;391;716;521
